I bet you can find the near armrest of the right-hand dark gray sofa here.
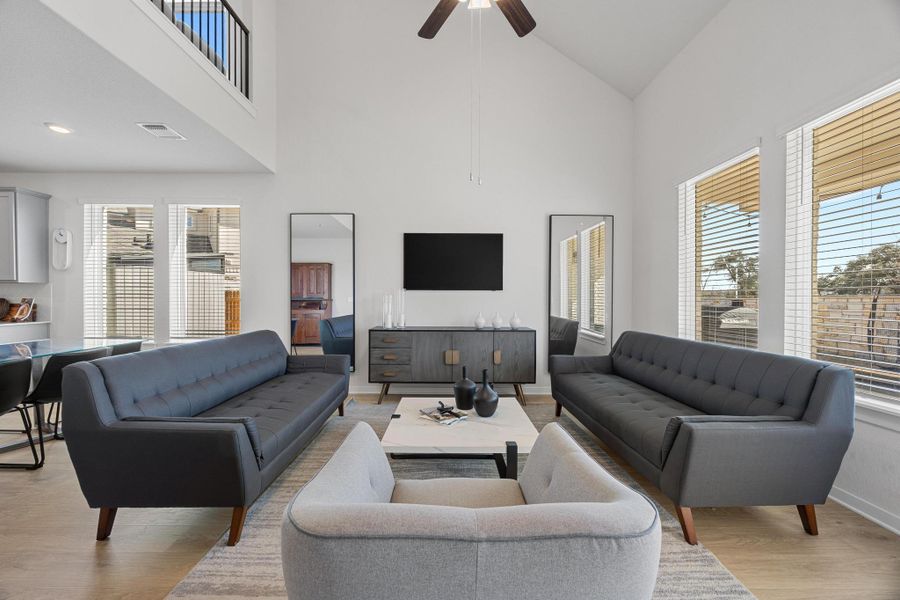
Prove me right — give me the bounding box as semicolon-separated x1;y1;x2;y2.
660;417;850;506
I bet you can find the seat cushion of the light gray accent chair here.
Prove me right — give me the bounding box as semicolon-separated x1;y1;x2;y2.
391;478;525;508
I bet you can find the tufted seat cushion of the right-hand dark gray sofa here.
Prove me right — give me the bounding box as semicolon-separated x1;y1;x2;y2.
555;373;703;467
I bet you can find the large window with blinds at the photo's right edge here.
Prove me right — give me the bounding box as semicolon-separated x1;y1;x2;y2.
785;82;900;401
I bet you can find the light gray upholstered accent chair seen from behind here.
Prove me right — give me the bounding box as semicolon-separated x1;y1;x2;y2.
281;423;661;600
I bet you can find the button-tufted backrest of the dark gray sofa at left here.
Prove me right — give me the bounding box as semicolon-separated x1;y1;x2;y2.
94;331;287;419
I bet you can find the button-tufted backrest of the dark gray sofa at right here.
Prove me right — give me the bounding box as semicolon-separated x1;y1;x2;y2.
611;331;826;419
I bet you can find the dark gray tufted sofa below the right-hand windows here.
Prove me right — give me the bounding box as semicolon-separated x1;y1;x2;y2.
550;331;854;544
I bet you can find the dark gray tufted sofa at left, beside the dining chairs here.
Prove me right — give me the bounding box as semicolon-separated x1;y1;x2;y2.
63;331;350;545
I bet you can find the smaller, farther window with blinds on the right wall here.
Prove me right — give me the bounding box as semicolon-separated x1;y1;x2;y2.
678;148;759;348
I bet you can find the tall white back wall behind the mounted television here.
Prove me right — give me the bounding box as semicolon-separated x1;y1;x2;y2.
0;0;633;391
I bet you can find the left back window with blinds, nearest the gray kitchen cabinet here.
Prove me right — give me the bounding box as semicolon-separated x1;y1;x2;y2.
84;204;154;339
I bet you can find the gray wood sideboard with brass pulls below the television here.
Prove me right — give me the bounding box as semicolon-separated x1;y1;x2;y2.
369;327;537;404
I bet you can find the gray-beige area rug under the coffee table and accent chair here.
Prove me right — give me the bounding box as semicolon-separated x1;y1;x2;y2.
169;400;754;600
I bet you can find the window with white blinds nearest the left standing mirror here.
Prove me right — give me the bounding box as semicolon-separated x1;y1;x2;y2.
169;204;241;339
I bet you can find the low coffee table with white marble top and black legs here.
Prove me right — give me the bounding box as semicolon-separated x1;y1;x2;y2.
381;398;538;479
